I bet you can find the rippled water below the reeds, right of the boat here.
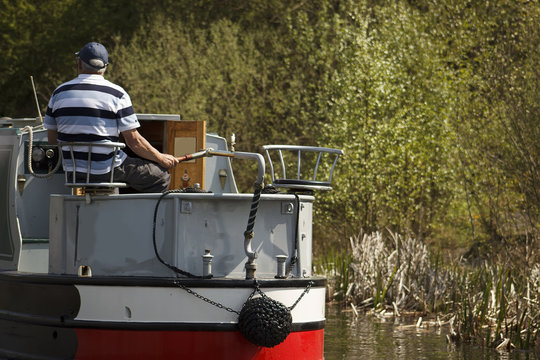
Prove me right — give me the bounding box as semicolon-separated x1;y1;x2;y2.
324;306;537;360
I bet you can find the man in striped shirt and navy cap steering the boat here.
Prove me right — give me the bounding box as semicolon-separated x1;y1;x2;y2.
44;42;178;192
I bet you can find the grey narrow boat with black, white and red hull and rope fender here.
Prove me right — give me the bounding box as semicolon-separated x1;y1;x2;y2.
0;114;342;360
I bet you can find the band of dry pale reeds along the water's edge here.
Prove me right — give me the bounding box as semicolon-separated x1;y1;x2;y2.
316;232;540;351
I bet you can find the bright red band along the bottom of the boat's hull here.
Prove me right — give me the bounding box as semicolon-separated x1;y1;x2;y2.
75;329;324;360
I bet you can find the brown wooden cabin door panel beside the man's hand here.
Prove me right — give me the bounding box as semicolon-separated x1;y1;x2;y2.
166;120;206;189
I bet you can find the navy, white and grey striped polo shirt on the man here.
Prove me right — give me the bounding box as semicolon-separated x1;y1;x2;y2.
44;74;140;174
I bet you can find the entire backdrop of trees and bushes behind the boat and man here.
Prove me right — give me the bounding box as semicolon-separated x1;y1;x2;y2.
0;0;540;252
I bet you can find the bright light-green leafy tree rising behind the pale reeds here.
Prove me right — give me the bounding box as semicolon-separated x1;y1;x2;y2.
314;3;453;242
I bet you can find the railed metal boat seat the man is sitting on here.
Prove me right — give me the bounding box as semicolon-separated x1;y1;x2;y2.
61;142;127;194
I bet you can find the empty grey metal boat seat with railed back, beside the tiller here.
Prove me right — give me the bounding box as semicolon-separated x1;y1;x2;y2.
262;145;343;191
